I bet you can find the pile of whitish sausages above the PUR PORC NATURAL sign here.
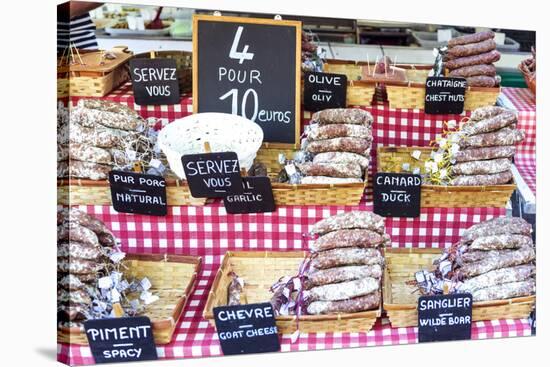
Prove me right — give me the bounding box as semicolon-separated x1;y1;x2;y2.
57;99;147;180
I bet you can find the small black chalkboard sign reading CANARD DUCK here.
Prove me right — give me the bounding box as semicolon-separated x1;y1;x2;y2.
373;172;422;218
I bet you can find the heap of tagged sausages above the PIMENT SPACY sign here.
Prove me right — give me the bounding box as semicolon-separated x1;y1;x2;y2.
57;208;158;328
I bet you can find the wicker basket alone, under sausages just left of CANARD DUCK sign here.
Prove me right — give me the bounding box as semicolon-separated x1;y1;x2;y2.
255;147;368;205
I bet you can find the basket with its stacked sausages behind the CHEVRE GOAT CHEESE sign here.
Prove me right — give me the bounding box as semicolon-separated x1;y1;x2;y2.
204;212;389;334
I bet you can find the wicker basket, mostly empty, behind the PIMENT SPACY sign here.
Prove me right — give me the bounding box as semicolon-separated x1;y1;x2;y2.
57;255;202;345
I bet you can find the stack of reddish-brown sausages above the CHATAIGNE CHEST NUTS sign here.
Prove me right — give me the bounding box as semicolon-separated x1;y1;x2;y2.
445;31;500;87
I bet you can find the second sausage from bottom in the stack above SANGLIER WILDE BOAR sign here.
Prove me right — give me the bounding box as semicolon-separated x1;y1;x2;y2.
459;264;536;293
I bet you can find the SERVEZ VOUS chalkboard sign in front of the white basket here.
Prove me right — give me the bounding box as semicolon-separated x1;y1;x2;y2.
181;152;243;198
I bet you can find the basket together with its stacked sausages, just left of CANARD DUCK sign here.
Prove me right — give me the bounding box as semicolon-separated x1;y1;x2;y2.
256;108;373;205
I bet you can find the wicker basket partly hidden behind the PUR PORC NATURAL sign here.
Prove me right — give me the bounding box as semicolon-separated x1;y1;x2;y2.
57;179;207;206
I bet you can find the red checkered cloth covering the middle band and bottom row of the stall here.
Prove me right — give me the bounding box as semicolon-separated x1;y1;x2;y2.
58;202;520;365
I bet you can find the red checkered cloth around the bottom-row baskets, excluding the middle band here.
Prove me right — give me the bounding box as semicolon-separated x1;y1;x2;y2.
58;260;531;365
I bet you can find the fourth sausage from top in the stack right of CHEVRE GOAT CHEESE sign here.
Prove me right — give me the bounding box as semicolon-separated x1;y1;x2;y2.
305;264;382;289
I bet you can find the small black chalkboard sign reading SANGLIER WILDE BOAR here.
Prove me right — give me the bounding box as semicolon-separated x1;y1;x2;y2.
418;293;473;343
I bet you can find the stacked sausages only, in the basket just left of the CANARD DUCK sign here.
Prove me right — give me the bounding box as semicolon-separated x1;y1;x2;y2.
297;108;373;184
